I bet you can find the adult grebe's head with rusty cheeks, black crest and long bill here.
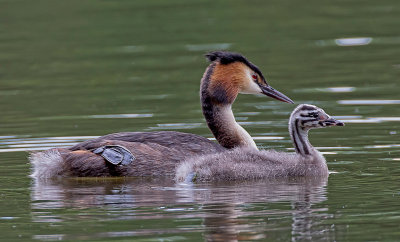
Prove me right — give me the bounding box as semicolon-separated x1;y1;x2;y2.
205;51;293;103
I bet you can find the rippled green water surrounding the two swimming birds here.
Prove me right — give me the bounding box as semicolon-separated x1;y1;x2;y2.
0;0;400;241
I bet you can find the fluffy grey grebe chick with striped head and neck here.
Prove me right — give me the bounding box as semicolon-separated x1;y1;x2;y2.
175;104;344;181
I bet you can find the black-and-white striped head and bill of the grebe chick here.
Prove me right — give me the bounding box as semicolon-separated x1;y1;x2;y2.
289;104;344;130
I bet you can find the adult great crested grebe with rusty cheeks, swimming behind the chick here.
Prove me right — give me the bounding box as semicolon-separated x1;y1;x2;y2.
29;51;293;178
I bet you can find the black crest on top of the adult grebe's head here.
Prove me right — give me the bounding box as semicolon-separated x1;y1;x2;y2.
205;51;264;79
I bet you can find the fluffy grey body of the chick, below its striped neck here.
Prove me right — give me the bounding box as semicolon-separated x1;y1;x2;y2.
176;148;328;181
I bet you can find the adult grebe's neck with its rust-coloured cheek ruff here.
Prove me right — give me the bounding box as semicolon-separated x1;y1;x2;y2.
200;62;257;149
